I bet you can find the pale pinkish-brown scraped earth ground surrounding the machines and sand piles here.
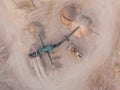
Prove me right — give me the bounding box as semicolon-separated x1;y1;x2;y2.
0;0;120;90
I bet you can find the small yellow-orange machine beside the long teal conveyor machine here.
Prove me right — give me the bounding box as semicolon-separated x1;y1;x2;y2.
68;44;81;61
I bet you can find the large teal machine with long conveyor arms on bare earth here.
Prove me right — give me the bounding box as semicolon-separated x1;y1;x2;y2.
29;26;80;64
